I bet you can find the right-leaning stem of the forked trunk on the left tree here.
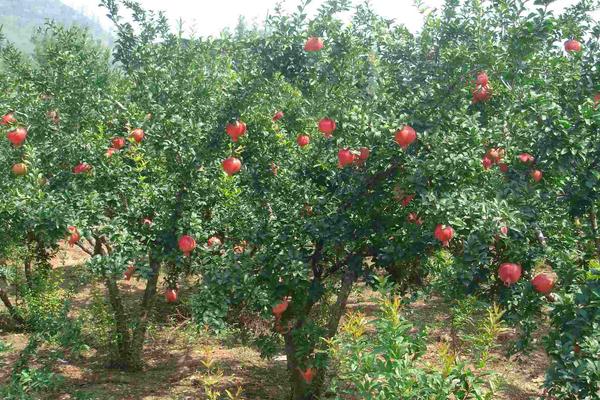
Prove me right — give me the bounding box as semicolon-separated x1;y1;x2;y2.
131;255;160;368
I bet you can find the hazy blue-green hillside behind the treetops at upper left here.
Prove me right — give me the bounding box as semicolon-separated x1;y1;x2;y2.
0;0;111;53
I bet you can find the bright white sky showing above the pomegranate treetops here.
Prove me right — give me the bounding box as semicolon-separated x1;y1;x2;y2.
62;0;600;36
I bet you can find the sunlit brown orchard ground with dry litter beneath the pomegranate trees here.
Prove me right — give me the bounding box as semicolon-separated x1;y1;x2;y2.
0;246;548;400
